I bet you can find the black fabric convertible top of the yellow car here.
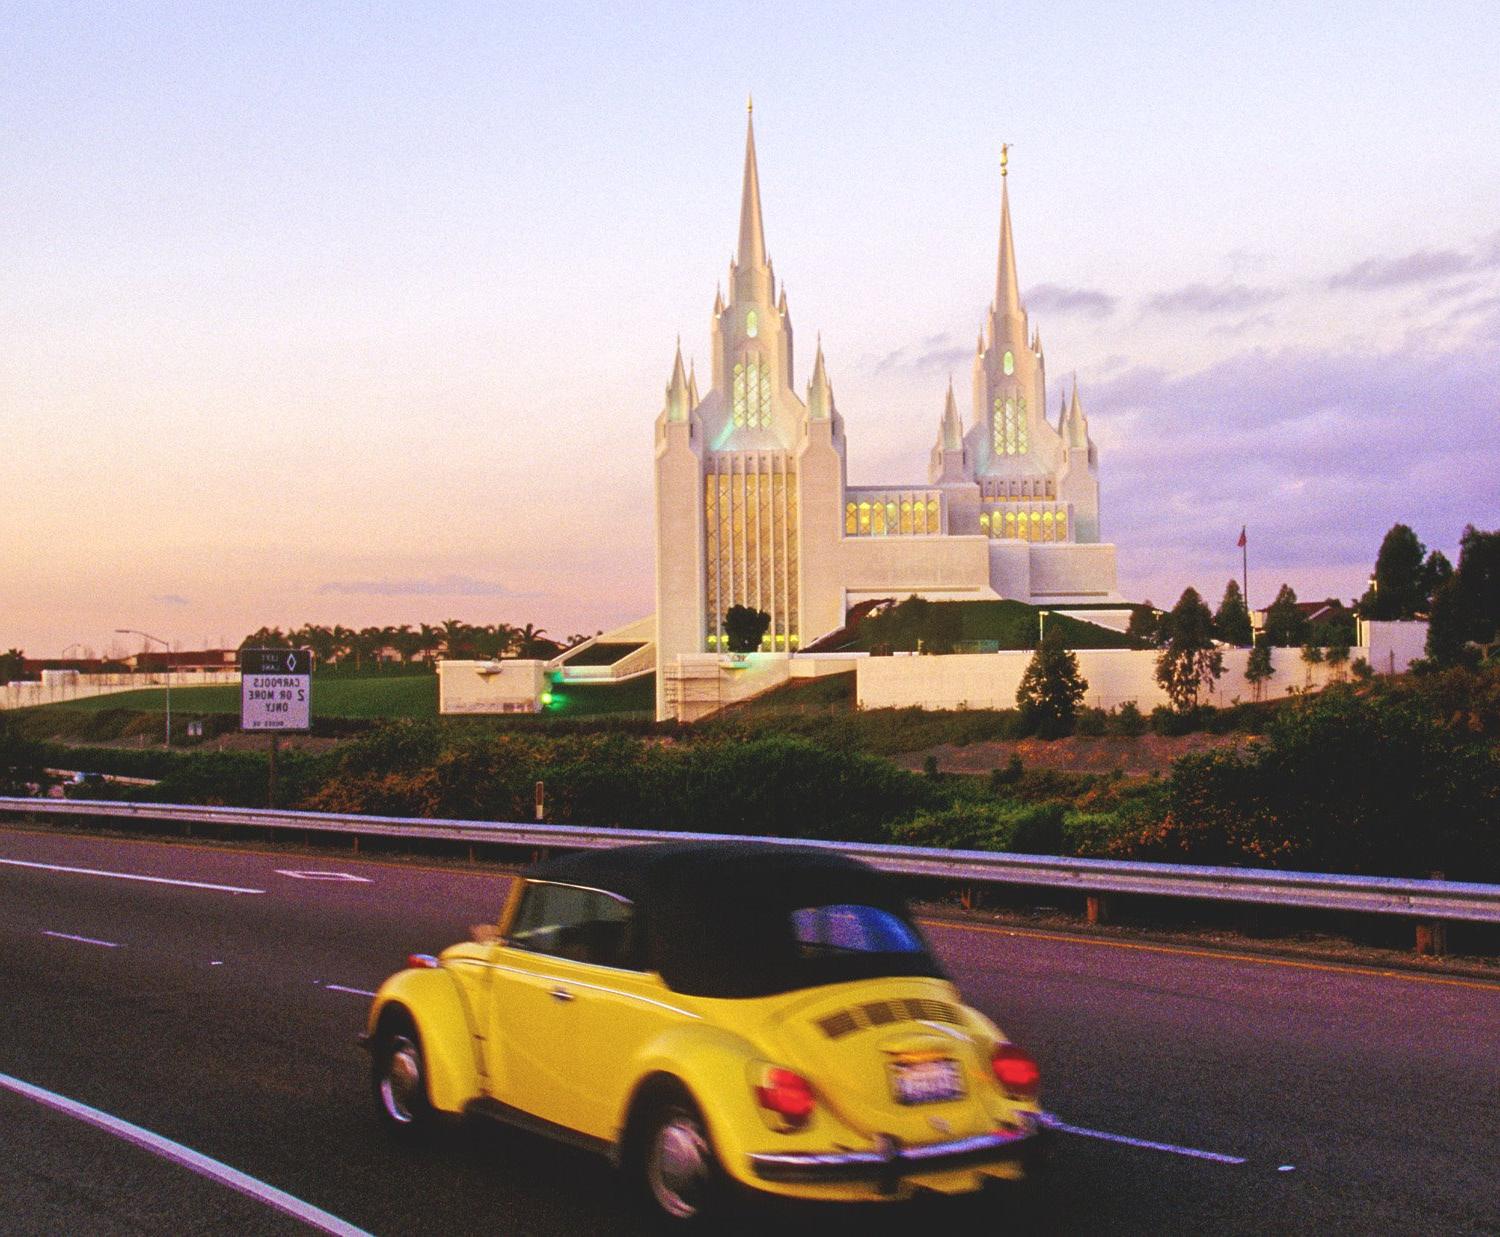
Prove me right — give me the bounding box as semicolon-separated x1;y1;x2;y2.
522;841;942;997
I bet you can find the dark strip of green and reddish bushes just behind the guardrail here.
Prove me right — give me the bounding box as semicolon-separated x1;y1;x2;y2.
0;669;1500;880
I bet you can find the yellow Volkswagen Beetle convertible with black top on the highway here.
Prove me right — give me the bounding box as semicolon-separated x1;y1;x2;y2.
362;841;1046;1225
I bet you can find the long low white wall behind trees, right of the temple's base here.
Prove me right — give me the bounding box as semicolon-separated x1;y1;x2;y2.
855;648;1367;712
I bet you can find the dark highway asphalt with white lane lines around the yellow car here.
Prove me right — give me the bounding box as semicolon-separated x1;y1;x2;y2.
0;829;1500;1234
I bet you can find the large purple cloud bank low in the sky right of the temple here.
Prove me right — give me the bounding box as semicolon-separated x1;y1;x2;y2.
1083;306;1500;600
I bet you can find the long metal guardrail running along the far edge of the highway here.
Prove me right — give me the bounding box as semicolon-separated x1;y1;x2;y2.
0;796;1500;924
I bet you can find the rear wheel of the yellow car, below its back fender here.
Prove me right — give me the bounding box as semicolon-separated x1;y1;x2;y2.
627;1086;728;1231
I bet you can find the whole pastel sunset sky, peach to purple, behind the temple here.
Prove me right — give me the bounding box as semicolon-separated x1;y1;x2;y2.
0;0;1500;655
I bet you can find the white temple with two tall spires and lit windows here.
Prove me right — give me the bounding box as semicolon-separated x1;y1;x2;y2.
656;113;1119;715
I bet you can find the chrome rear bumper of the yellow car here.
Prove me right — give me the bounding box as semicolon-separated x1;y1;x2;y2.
750;1114;1047;1194
